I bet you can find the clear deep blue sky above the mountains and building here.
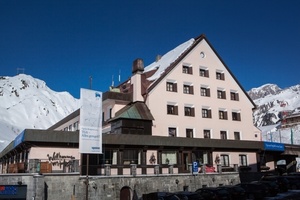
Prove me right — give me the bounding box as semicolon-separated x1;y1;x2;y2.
0;0;300;98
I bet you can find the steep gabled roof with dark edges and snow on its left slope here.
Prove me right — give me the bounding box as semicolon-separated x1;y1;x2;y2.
145;34;256;109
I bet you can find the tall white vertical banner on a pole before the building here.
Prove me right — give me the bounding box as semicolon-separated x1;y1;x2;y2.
79;88;102;154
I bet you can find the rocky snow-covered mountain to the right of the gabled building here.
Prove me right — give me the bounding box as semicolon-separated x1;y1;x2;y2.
248;84;300;127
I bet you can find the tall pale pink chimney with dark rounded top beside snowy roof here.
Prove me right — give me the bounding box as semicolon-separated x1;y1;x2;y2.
131;58;144;102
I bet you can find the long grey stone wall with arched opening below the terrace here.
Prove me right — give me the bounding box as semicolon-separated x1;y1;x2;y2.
0;172;240;200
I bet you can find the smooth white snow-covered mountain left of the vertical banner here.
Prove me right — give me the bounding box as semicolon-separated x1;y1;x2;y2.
0;74;79;152
